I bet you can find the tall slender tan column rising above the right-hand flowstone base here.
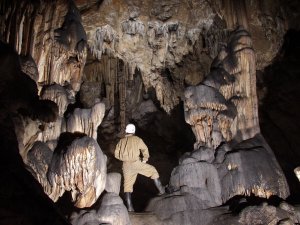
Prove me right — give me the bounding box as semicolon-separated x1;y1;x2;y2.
223;29;259;140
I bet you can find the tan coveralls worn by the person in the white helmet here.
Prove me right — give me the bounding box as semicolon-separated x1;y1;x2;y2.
115;134;159;192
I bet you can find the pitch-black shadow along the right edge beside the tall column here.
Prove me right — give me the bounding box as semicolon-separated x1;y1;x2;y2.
258;30;300;203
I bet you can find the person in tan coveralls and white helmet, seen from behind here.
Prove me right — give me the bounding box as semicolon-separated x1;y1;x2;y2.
115;124;165;212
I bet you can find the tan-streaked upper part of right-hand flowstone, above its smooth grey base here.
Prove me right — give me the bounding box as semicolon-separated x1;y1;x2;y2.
184;28;259;149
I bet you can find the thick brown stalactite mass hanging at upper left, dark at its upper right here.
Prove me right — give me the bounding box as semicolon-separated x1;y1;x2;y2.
32;0;87;92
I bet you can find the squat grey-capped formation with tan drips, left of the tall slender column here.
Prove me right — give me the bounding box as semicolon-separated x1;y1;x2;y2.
184;85;233;149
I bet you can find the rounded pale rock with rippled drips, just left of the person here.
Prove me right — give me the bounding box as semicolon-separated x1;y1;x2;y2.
48;137;107;208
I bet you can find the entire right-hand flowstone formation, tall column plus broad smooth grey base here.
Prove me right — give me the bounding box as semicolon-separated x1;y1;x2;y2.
147;27;290;224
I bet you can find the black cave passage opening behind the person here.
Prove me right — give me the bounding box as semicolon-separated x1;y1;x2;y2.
98;103;195;212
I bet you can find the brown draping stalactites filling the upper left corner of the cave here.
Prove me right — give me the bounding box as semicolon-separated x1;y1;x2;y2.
0;0;87;94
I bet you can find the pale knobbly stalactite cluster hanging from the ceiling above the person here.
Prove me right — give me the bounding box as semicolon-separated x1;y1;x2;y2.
88;18;188;112
